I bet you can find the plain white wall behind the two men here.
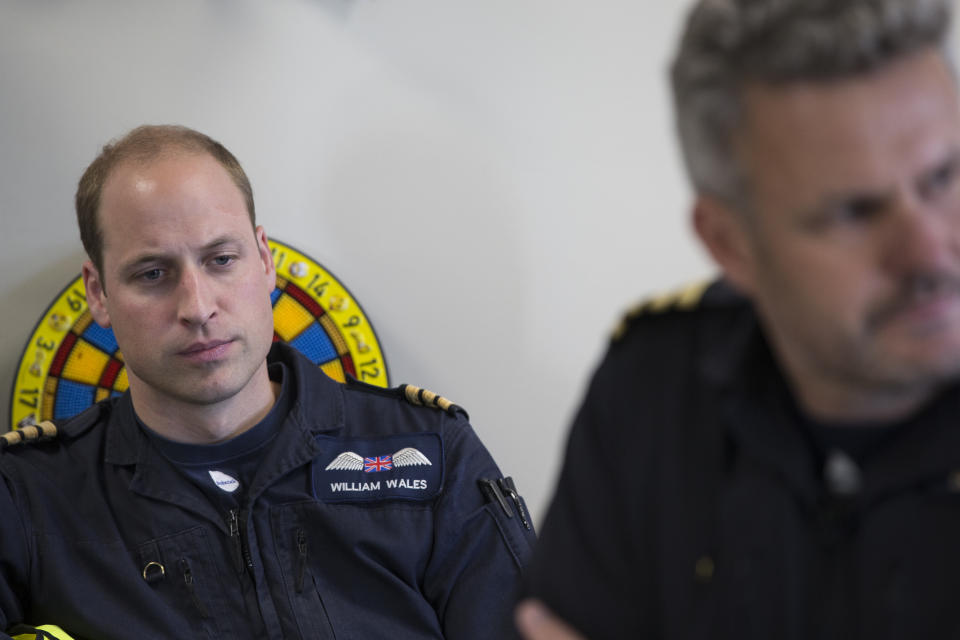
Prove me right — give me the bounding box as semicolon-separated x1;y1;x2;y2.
0;0;711;522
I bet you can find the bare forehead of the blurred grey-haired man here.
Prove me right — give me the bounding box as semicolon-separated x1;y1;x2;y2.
731;50;960;220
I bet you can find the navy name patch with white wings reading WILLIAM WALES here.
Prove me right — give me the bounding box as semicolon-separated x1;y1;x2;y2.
311;433;443;502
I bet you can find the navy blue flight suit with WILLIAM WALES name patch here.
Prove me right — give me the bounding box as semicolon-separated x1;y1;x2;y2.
0;345;533;640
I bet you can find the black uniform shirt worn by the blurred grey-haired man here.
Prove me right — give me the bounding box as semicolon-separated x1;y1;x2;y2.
527;284;960;640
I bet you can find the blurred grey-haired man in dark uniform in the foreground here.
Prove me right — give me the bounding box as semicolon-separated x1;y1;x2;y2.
518;0;960;640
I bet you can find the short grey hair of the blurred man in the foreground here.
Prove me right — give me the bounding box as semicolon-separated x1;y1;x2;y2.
671;0;952;206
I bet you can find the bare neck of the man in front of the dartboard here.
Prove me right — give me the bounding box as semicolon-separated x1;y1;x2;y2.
130;362;280;444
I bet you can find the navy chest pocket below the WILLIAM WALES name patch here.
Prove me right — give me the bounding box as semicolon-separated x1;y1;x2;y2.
271;500;443;640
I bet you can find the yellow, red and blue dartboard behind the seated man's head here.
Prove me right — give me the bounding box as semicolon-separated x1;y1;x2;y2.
10;240;389;429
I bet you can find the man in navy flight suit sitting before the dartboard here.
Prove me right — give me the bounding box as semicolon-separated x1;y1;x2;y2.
0;126;533;640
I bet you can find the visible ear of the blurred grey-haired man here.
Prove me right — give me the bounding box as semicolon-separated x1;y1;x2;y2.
693;196;757;295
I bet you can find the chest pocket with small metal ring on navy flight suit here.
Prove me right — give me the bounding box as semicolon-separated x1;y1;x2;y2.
138;527;233;638
